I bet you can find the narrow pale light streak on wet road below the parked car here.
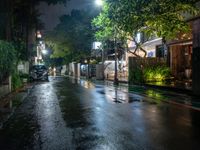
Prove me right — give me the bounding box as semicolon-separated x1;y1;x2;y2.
36;83;71;150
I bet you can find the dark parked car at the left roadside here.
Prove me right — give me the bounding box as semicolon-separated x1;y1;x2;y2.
29;65;49;81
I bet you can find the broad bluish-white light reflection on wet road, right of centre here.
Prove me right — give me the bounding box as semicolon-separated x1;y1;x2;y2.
91;86;152;149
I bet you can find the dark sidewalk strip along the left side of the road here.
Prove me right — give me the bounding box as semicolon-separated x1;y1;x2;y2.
0;84;33;129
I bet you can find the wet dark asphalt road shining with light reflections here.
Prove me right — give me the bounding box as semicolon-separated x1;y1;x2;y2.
0;77;200;150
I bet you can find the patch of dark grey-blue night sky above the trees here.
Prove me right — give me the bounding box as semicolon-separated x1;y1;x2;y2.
38;0;94;31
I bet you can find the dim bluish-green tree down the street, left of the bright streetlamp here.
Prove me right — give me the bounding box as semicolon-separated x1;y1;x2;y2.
46;10;97;63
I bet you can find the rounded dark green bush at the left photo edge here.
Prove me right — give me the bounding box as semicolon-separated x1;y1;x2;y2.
0;41;17;82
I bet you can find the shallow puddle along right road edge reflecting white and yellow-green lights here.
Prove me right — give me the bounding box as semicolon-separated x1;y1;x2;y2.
68;79;189;105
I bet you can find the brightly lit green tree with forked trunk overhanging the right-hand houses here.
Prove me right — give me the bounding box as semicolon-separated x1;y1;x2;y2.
94;0;199;57
